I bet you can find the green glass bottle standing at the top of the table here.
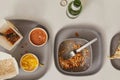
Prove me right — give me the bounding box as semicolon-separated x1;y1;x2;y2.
66;0;82;19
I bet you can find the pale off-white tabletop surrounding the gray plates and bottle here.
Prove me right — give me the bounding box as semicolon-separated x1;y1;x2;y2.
0;0;120;80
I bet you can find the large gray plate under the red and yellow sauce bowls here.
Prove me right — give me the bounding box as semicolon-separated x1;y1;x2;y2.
0;20;52;80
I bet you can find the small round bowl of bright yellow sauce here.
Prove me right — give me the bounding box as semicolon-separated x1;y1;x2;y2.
20;53;39;72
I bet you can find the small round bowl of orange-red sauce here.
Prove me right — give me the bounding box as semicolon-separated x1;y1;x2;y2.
30;28;47;46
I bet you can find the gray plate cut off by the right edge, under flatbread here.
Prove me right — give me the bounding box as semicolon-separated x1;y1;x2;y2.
110;33;120;70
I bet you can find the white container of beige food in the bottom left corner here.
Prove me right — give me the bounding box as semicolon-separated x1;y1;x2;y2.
0;52;19;80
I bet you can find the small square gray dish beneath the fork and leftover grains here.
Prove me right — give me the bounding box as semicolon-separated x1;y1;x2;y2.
57;38;92;74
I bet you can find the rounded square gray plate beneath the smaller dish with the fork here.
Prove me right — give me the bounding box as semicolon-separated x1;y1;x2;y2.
54;25;104;76
